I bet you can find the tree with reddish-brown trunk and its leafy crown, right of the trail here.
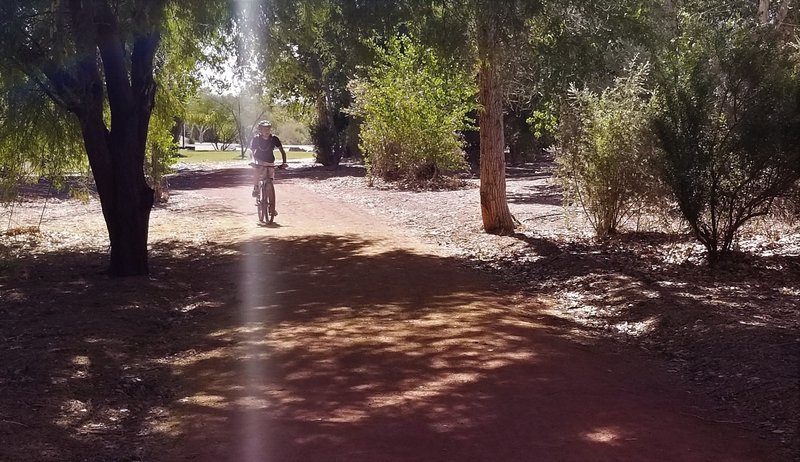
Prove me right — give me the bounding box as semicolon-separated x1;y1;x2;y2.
407;0;653;234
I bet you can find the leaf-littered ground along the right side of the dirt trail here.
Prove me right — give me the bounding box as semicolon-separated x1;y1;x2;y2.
290;162;800;458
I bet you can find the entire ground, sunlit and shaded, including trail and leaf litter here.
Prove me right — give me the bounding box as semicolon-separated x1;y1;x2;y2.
0;161;798;461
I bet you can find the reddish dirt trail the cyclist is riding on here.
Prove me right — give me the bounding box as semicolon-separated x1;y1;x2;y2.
156;169;781;462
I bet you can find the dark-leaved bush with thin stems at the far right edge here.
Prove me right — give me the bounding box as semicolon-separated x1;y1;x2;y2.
655;12;800;264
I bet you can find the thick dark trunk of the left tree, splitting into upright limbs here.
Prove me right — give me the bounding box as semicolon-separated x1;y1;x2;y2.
91;13;160;276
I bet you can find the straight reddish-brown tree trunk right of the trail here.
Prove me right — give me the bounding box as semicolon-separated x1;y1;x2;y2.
478;15;514;234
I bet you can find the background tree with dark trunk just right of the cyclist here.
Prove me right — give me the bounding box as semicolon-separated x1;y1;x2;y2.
257;0;379;165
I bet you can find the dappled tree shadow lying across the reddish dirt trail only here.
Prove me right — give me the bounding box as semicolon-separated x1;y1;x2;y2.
167;236;780;461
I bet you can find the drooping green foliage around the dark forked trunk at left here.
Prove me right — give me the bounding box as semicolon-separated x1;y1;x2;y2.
0;0;230;201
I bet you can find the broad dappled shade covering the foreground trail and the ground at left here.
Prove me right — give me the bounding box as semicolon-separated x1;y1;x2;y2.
0;235;788;461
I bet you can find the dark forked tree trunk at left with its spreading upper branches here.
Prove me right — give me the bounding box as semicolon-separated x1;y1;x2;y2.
14;0;159;276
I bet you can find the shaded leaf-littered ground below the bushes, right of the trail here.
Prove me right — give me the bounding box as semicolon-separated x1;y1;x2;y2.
493;233;800;453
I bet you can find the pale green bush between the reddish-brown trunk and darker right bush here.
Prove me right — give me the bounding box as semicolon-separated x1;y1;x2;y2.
556;64;651;237
